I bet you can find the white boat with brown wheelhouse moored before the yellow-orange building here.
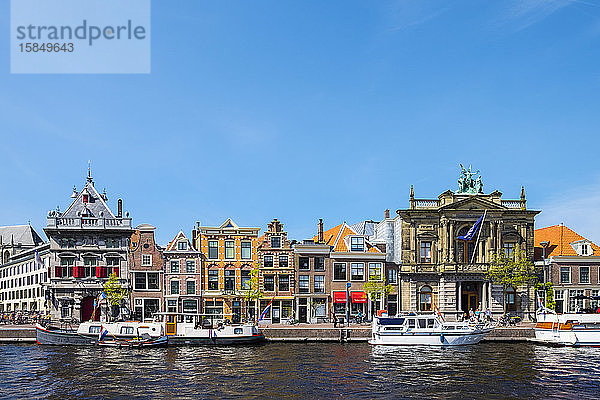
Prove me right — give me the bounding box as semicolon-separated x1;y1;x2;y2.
156;313;265;345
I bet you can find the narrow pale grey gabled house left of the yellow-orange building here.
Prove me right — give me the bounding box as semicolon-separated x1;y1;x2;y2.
163;230;204;314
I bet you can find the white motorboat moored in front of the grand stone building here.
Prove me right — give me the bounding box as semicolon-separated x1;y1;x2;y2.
369;314;493;346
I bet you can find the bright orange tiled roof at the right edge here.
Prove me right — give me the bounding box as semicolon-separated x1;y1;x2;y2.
533;225;600;260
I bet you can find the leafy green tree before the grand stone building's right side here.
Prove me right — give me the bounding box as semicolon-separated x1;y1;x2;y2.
486;244;538;312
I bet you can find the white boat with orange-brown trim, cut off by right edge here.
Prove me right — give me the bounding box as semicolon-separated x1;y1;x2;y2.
535;308;600;346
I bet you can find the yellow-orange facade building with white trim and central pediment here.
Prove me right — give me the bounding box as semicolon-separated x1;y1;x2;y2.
192;218;260;322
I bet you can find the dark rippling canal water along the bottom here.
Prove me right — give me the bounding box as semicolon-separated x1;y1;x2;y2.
0;343;600;399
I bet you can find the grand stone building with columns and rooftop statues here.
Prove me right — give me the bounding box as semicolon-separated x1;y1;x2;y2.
397;168;539;320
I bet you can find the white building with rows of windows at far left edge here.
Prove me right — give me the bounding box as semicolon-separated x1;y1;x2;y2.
0;241;50;313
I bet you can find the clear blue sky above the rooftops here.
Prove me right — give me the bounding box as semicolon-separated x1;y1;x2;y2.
0;0;600;243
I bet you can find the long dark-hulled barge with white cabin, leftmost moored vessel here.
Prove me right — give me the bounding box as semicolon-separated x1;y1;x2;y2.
35;321;164;346
